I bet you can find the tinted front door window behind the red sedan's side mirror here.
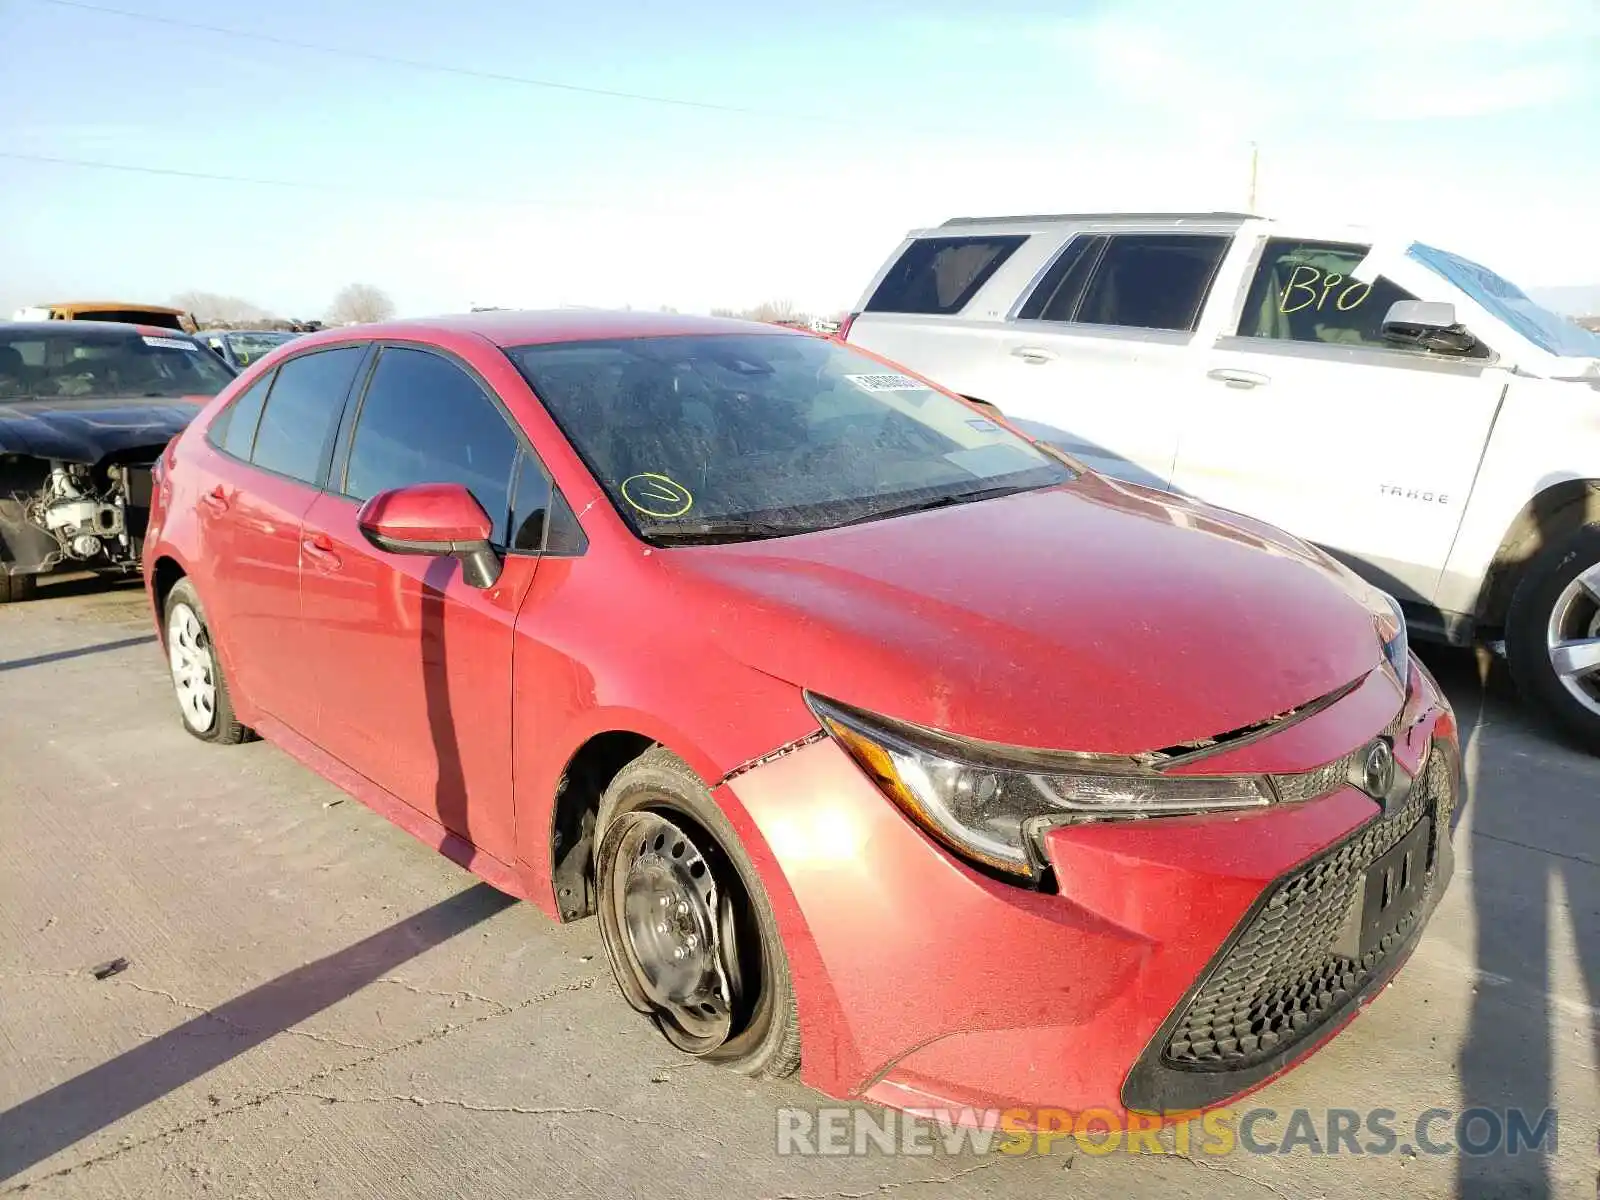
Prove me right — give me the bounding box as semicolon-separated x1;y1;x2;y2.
344;346;518;547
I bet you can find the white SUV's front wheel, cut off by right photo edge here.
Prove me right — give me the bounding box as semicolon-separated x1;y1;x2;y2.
1506;525;1600;754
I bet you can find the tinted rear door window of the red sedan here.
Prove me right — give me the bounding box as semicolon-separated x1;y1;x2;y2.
250;346;366;485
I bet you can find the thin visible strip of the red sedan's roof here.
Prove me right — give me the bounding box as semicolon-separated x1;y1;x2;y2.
297;309;796;347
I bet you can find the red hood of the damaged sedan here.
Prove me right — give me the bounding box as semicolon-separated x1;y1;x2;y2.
661;474;1382;754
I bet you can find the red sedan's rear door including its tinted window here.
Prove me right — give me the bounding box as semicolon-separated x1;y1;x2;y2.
197;346;365;733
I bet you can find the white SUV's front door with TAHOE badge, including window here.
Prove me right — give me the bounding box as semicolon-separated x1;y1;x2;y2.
1173;234;1509;602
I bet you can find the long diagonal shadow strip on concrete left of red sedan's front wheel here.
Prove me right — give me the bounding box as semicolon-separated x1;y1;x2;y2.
0;883;514;1179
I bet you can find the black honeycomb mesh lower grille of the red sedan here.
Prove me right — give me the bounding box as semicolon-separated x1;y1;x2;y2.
1162;747;1454;1070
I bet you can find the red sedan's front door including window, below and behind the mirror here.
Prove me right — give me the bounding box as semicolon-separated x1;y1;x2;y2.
301;344;539;862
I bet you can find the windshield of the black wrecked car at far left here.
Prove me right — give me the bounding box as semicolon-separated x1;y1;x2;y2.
0;322;234;402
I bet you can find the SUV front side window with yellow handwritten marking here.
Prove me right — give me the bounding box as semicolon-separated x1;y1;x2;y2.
1238;237;1416;349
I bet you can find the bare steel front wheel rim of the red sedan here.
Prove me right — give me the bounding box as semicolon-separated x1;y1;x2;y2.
600;810;741;1054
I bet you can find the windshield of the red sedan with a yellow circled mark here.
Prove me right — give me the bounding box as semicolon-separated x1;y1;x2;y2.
507;333;1074;542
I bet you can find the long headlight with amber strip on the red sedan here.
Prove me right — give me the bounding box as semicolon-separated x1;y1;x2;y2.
806;694;1274;878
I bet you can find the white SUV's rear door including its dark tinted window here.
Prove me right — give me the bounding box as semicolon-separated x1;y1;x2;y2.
984;230;1230;488
